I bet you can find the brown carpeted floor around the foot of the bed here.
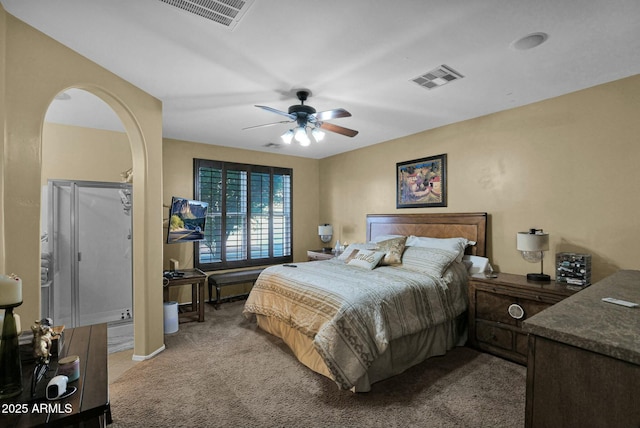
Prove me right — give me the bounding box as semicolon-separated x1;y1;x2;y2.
110;301;526;428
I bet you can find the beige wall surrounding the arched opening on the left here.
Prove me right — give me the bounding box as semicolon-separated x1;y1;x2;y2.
0;7;164;359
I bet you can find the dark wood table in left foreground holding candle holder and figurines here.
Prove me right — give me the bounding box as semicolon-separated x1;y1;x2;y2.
0;324;111;427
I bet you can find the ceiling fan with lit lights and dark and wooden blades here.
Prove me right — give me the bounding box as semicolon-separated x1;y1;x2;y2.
243;89;358;146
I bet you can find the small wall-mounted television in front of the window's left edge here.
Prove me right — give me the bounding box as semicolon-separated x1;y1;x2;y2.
167;196;209;244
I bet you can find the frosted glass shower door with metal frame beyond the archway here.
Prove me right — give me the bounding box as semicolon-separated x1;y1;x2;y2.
50;181;133;327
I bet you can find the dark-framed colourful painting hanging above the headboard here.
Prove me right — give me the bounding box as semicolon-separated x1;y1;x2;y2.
396;154;447;208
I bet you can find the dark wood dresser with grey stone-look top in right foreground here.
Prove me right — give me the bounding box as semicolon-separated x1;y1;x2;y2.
524;270;640;427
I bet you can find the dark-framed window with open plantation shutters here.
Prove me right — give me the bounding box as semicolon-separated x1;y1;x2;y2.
193;159;293;270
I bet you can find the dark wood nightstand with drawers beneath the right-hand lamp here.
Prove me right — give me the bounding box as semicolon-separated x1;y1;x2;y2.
469;273;576;364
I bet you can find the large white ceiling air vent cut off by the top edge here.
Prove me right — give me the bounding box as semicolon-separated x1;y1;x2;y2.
160;0;255;30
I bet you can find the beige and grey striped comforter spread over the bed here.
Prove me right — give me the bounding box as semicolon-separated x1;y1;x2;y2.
244;259;467;389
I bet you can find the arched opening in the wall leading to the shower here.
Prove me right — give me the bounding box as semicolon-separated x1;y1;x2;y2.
40;88;134;353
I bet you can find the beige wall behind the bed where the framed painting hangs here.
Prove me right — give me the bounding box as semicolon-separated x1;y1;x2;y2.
320;75;640;281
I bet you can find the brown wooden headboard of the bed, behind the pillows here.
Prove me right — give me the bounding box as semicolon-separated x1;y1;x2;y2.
367;213;487;256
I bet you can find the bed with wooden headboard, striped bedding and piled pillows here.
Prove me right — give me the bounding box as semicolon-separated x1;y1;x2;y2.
244;213;487;392
